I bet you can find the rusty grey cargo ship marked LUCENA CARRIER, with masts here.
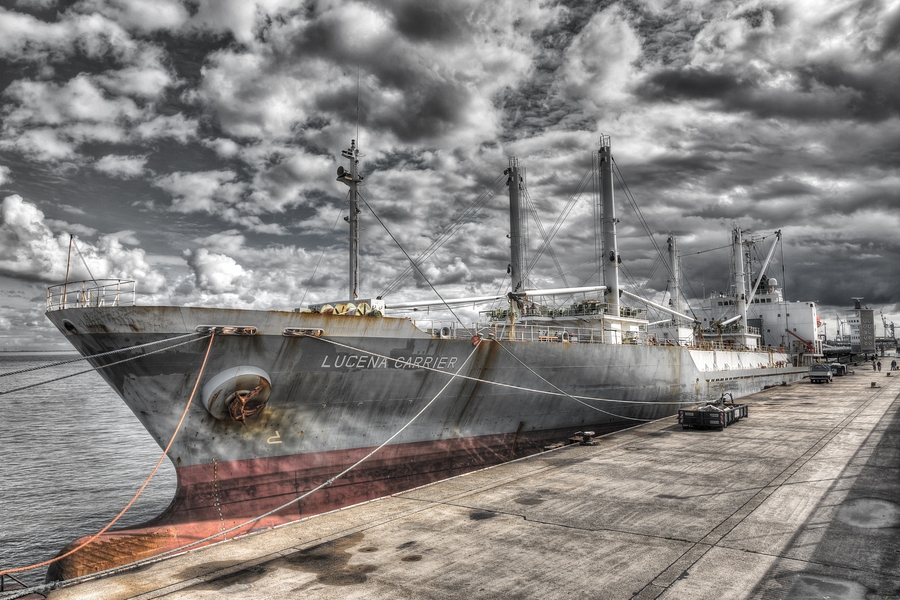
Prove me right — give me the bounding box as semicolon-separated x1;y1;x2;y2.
46;136;805;580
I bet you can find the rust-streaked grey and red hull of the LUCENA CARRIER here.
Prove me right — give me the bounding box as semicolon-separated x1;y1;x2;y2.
48;307;802;579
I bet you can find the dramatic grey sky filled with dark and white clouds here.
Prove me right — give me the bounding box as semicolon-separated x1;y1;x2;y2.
0;0;900;350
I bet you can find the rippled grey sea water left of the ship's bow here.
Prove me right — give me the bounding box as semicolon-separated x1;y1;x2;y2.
0;353;175;584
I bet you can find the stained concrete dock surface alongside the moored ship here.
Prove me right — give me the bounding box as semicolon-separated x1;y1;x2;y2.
49;368;900;600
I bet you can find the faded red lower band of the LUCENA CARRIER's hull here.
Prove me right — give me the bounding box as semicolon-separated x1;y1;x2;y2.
47;425;596;580
